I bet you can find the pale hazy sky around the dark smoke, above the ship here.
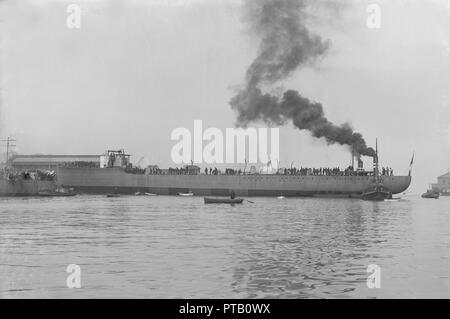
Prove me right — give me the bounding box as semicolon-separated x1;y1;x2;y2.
0;0;450;191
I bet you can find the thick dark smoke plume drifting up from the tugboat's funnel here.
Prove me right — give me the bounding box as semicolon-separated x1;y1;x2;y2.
230;0;375;156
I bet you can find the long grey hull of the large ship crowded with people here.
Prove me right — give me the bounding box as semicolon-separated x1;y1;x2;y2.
56;167;411;197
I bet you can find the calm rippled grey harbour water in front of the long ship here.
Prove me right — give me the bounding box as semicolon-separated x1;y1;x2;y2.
0;196;450;298
